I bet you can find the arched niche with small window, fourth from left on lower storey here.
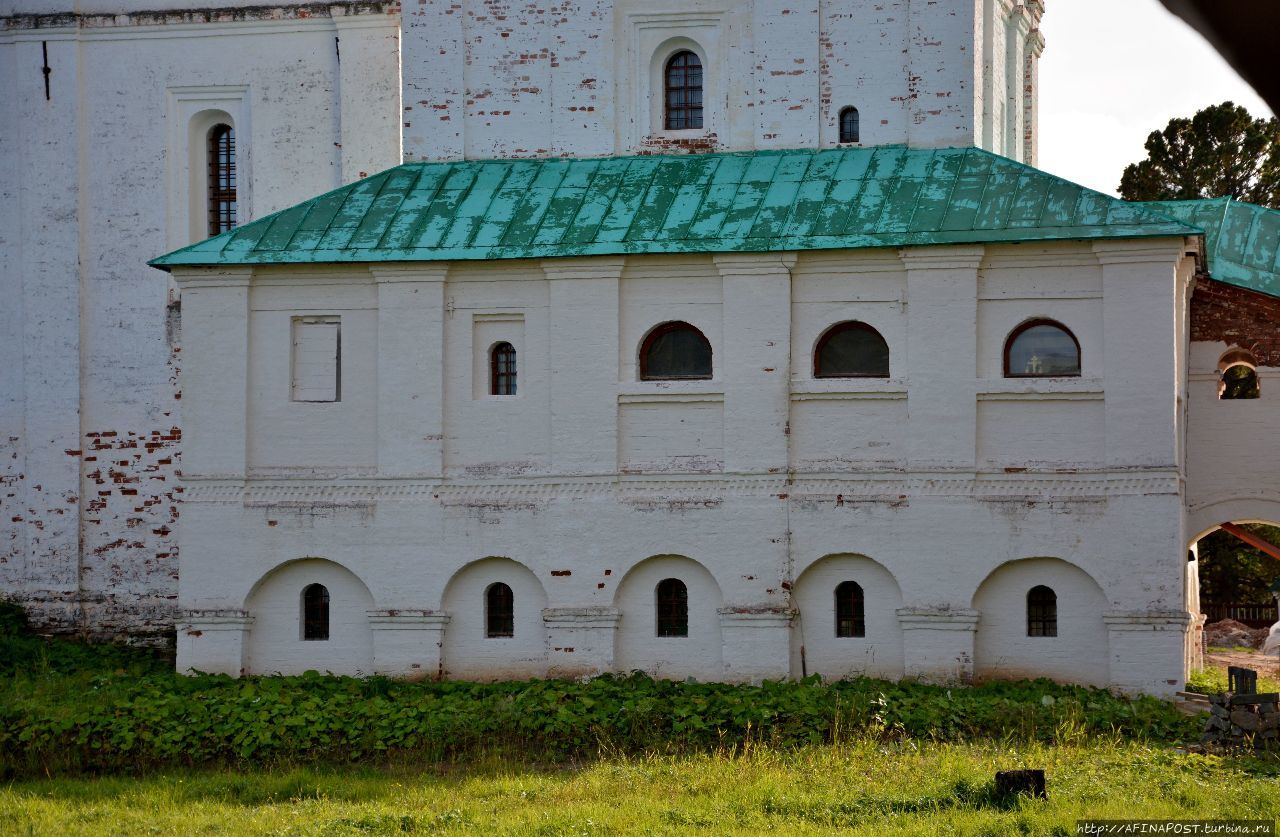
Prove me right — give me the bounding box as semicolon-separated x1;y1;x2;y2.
791;554;904;680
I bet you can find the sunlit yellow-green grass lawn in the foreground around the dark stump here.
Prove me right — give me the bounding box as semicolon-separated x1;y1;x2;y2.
0;738;1280;837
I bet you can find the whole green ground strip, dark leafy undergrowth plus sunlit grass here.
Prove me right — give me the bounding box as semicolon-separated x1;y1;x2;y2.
0;608;1280;834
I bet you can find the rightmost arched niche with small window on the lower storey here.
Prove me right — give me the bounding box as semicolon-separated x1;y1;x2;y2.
973;558;1110;686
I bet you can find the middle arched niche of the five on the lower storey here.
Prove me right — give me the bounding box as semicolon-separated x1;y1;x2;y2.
613;555;723;681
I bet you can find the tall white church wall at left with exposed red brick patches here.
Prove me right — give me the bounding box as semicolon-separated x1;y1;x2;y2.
0;4;399;637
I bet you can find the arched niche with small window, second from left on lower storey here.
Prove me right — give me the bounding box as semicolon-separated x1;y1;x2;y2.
442;557;547;680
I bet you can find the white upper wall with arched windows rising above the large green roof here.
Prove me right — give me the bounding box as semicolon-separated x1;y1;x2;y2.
403;0;1043;161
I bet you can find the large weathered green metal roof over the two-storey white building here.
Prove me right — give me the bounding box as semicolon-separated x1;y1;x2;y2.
151;146;1199;267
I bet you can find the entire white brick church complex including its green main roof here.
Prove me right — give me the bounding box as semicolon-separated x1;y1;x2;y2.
0;0;1280;694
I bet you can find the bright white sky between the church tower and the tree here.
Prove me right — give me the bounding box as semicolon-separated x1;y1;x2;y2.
1038;0;1272;195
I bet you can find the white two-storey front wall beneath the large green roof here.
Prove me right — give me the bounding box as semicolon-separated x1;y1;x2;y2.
175;241;1192;694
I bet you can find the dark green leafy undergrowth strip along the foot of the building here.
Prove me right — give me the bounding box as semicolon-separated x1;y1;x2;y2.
0;612;1199;778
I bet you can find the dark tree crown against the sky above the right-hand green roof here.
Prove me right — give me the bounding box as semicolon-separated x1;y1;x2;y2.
1120;101;1280;209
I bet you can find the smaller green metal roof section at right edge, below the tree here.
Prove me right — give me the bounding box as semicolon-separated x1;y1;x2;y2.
1142;197;1280;297
